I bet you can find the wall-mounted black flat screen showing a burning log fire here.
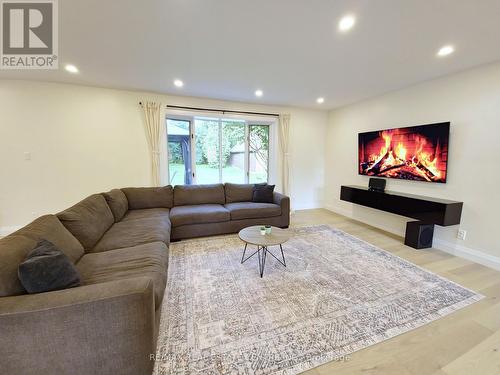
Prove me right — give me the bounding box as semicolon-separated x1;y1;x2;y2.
358;122;450;183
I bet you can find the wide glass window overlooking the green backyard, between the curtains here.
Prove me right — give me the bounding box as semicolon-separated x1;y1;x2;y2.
167;117;271;185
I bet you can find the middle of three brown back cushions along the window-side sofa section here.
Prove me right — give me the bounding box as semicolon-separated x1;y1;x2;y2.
174;184;226;206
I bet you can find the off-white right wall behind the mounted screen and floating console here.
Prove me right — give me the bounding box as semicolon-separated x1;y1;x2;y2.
325;63;500;267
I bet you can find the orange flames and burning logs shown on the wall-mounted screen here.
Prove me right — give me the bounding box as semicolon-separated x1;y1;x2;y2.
365;131;443;181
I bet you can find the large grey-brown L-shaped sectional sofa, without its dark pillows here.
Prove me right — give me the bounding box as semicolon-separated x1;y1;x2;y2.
0;184;290;374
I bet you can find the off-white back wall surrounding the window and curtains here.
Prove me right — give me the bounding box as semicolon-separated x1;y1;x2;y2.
0;80;328;235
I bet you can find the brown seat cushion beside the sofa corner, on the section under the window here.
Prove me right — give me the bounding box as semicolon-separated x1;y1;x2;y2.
170;204;230;227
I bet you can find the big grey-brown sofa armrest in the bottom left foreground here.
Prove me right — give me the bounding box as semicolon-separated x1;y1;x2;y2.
0;277;155;374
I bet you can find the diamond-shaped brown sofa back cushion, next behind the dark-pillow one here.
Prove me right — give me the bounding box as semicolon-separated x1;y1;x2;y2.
57;194;115;250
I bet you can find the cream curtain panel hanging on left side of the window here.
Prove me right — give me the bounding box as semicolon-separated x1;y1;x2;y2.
142;102;164;186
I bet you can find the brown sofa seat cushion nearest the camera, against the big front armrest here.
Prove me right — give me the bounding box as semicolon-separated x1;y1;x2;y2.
76;242;168;307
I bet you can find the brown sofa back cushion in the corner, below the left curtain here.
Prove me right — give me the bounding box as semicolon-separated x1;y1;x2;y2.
122;185;174;210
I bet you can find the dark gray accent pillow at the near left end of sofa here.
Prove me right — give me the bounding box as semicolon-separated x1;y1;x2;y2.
17;240;80;294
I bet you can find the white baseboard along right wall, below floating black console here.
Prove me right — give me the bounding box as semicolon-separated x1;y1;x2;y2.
325;205;500;270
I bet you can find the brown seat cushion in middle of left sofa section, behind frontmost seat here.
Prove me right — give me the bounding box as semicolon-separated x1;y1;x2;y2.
90;216;170;253
